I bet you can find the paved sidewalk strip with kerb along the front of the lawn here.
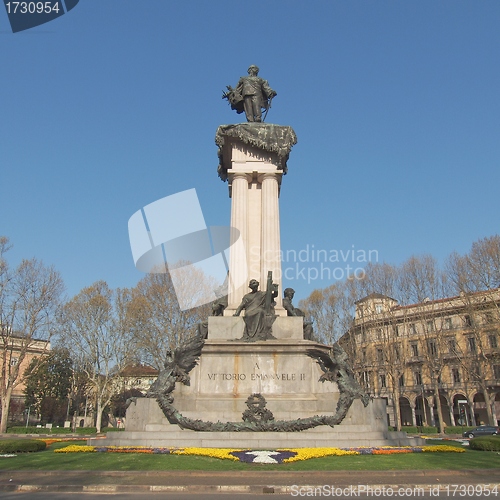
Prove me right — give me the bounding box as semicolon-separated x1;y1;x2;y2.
0;469;500;494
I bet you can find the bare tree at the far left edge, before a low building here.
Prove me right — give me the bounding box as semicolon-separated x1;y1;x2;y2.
0;237;64;433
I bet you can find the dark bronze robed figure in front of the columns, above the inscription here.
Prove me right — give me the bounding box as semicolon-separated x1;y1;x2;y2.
233;273;278;342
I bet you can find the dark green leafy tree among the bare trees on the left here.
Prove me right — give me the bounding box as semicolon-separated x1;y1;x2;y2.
24;349;73;424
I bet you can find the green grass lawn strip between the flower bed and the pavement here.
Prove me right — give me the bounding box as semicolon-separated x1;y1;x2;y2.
0;440;500;471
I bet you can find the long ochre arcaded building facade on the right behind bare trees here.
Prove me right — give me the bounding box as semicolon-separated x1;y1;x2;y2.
340;289;500;427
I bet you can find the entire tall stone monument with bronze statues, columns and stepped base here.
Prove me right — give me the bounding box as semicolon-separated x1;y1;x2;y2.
101;66;417;449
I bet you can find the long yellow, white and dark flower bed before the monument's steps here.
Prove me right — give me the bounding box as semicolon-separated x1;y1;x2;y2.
54;445;465;464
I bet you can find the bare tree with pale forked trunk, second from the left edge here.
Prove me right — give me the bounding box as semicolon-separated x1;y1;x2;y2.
61;281;135;432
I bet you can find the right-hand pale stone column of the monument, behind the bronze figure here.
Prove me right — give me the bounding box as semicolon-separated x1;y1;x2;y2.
258;172;283;309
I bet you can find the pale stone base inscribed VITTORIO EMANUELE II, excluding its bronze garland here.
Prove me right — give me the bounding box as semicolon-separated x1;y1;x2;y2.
96;317;420;449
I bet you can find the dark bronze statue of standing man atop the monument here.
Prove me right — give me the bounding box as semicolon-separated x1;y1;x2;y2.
222;65;277;122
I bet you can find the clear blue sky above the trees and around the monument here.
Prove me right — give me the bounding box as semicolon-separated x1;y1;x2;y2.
0;0;500;301
